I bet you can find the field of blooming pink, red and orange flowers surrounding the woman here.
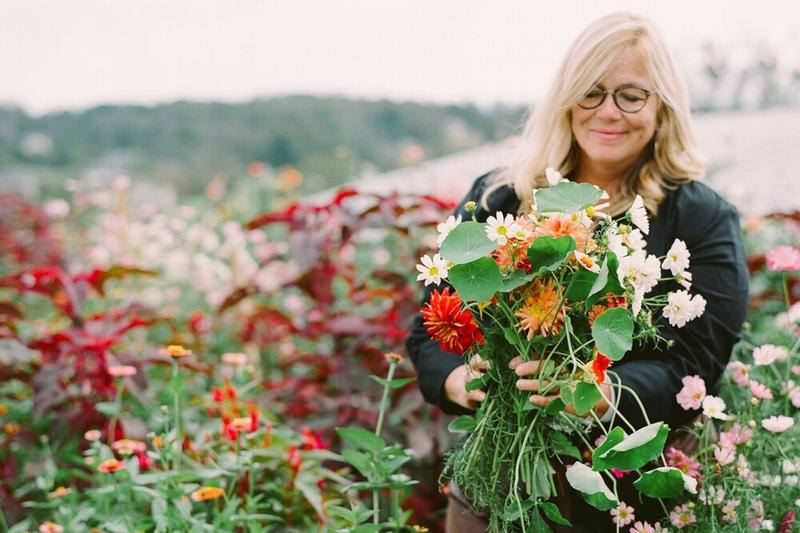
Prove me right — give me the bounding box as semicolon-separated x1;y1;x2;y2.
0;173;800;532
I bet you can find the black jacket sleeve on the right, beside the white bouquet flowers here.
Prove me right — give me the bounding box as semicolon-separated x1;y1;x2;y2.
612;186;748;428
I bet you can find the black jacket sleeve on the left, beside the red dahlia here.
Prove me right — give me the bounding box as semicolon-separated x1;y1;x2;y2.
406;174;489;414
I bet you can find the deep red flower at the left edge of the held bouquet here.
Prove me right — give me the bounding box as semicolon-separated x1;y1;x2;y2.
422;287;484;354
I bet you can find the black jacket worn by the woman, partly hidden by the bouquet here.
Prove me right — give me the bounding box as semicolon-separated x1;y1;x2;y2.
406;169;748;430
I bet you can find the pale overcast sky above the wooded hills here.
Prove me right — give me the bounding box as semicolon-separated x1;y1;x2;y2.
0;0;800;113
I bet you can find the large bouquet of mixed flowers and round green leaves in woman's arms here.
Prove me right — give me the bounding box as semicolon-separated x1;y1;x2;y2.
417;169;706;531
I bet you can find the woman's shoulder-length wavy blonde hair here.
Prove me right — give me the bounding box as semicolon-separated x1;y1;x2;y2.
482;13;704;215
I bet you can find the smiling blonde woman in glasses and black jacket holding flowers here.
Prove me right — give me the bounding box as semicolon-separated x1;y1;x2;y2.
407;13;748;532
